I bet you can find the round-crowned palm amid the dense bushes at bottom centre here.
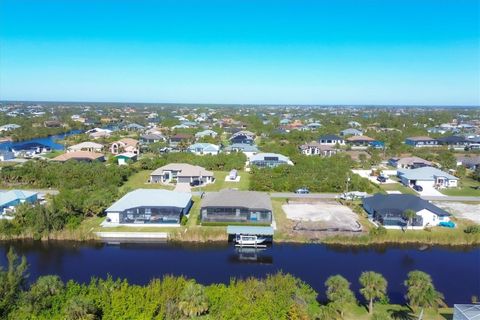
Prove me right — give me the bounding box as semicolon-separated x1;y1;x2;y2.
178;281;208;318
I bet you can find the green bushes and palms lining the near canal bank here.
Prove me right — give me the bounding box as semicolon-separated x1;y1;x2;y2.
0;249;444;320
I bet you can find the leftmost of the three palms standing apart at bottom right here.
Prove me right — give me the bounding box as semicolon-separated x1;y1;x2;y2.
325;275;356;317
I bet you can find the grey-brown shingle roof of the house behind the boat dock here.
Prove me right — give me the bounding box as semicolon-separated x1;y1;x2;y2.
201;189;272;211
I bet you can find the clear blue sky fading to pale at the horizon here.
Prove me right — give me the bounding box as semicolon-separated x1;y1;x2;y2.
0;0;480;105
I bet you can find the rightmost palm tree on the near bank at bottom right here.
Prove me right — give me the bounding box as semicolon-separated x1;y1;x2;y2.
405;270;445;319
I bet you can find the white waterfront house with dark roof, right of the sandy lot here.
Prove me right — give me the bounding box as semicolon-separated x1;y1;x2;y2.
363;193;450;229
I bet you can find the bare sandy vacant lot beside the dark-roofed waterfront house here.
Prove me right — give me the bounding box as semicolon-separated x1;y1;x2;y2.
282;201;359;230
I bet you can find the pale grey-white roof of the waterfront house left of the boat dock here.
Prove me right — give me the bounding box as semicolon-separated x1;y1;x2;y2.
105;189;192;212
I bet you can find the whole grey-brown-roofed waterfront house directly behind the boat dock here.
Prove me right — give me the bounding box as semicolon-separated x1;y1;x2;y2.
200;189;272;224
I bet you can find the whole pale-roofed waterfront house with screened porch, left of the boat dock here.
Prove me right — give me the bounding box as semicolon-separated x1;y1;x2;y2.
105;189;192;226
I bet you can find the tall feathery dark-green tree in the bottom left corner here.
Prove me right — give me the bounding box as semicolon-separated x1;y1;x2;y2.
0;247;28;319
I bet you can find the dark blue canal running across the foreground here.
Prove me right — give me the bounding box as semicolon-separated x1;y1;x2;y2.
0;241;480;305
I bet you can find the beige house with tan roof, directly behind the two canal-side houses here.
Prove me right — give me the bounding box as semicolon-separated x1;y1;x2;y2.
149;163;215;184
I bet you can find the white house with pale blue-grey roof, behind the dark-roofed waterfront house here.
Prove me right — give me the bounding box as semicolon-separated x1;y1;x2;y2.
397;167;458;188
